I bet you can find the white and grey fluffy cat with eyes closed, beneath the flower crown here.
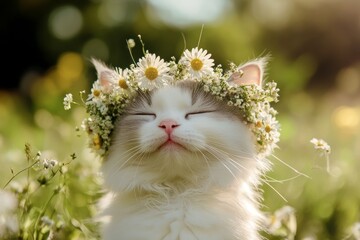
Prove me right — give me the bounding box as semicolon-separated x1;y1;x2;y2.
95;59;270;240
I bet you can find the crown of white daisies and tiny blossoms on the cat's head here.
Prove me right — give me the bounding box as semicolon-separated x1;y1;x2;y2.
64;41;280;156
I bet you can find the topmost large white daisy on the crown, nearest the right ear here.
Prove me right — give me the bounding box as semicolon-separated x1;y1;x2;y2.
180;47;214;77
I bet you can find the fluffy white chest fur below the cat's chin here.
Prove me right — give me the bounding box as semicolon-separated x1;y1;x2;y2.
103;181;261;240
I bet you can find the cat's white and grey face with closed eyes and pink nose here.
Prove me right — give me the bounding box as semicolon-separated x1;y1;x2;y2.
103;82;256;190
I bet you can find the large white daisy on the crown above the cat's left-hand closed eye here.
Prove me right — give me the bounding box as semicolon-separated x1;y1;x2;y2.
134;53;171;90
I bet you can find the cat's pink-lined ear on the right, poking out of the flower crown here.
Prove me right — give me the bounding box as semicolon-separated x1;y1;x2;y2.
228;58;267;86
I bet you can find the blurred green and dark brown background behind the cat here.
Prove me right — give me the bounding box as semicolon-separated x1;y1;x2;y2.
0;0;360;239
